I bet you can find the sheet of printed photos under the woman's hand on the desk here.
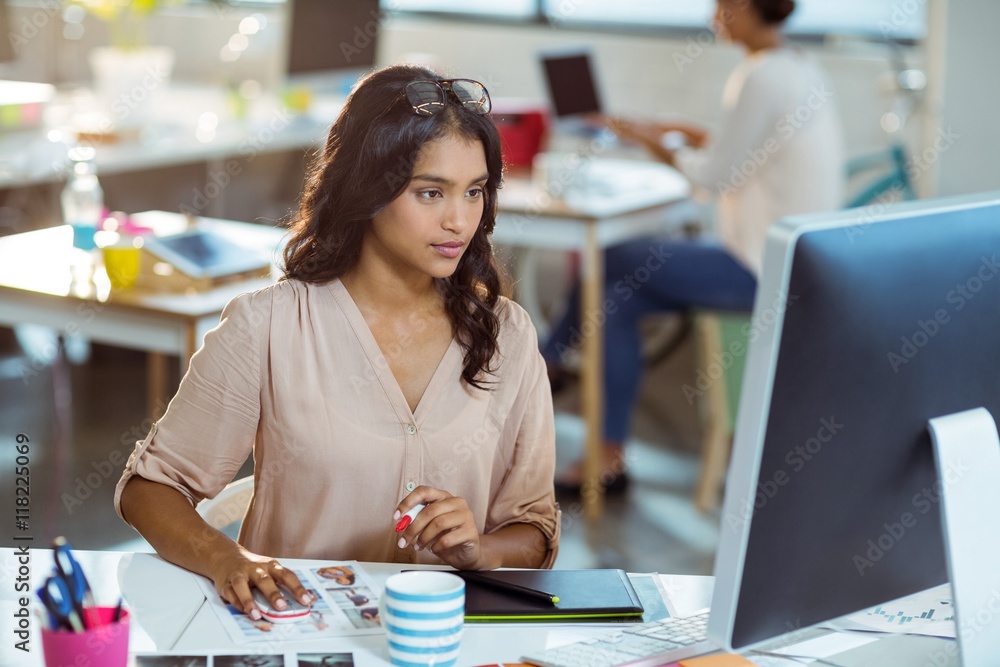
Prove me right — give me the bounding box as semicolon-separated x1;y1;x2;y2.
194;561;382;648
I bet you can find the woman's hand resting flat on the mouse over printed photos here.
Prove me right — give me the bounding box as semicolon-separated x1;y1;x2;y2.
211;547;315;621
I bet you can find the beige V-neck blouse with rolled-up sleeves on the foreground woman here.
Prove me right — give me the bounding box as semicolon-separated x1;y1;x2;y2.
115;280;560;567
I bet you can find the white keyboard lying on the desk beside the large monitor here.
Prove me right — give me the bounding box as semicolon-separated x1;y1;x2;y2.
521;612;716;667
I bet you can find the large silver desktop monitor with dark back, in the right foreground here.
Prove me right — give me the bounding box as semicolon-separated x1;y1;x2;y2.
709;193;1000;665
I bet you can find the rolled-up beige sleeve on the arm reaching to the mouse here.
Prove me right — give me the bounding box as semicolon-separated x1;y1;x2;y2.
114;294;269;519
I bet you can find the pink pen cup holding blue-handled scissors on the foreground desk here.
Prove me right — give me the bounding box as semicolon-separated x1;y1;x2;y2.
42;607;129;667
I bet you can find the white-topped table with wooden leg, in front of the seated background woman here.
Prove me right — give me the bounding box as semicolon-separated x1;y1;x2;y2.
493;158;690;518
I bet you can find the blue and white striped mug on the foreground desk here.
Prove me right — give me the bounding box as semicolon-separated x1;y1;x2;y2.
380;570;465;667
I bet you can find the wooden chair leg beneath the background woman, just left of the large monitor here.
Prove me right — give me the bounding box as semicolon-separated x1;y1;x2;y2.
694;313;732;512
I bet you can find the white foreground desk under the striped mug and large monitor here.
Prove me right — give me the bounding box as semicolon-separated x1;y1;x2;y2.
0;548;957;667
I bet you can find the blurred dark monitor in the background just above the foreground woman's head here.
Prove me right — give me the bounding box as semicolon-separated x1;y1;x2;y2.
285;0;384;94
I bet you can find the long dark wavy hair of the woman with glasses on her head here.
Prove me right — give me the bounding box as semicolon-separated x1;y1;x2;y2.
282;65;509;389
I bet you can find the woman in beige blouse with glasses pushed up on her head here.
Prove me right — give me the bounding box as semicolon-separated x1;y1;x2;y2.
115;66;559;617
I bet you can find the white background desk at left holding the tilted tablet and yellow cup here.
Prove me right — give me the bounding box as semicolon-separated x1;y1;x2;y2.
0;214;285;418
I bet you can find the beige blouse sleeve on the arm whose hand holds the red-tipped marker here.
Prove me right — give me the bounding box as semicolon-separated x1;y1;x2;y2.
485;304;561;568
